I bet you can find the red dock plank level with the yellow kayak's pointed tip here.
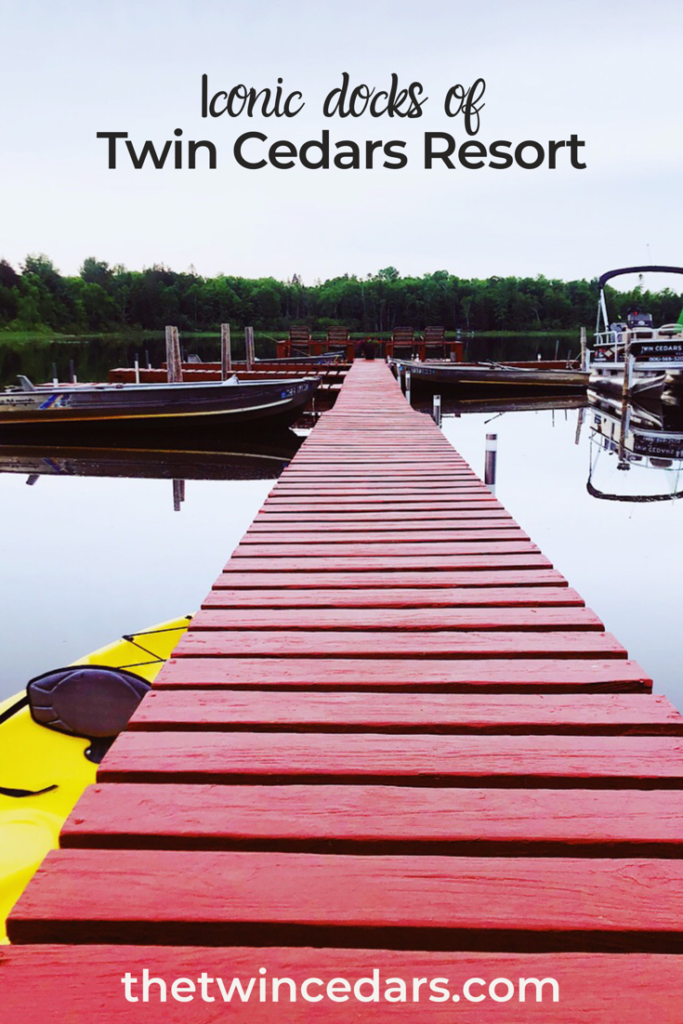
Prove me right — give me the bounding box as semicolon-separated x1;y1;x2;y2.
189;606;604;632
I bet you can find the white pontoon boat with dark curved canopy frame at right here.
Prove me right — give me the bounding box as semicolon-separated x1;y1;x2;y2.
590;265;683;394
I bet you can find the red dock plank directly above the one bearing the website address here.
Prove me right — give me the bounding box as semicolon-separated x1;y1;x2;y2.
9;850;683;952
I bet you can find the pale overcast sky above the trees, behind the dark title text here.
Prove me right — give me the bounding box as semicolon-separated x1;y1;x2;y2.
0;0;683;283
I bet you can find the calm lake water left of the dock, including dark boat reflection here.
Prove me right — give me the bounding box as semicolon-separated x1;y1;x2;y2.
0;430;303;699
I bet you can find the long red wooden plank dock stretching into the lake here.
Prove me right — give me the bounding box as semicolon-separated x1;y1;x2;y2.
0;361;683;1024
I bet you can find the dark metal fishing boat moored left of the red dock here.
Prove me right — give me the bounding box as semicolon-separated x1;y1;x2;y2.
0;375;319;428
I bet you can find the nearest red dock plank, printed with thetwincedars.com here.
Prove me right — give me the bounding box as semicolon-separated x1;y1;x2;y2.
5;945;683;1024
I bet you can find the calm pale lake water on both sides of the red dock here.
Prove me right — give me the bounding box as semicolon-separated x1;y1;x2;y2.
0;344;683;710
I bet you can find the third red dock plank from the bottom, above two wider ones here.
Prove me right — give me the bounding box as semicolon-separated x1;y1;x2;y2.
60;782;683;857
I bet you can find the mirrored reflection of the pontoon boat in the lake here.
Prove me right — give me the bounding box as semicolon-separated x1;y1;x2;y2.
587;392;683;502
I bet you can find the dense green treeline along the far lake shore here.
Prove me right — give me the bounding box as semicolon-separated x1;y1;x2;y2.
0;255;682;334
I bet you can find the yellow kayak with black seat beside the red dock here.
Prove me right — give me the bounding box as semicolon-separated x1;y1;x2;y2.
0;616;189;943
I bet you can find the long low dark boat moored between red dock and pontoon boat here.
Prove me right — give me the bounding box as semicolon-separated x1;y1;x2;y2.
389;359;589;394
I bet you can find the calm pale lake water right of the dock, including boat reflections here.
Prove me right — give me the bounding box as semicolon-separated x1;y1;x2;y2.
421;396;683;710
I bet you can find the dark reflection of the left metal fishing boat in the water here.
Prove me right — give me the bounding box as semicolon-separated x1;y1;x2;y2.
0;429;304;511
